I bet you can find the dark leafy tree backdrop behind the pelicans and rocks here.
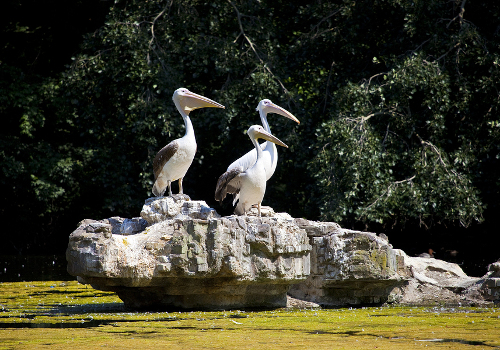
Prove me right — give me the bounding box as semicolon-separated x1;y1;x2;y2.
0;0;500;275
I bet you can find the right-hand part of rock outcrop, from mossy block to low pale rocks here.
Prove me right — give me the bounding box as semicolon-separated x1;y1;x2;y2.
289;219;494;307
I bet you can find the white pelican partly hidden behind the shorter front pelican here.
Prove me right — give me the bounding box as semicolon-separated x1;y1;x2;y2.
227;99;300;205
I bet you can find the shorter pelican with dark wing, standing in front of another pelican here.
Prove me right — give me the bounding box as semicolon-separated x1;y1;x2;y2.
215;125;288;217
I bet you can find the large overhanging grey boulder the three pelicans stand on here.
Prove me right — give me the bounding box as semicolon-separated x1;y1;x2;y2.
66;199;311;309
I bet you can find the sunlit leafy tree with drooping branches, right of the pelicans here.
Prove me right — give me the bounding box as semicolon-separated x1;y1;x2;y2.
314;1;499;228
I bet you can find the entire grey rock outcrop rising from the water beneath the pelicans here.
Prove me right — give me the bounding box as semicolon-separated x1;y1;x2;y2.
66;197;500;309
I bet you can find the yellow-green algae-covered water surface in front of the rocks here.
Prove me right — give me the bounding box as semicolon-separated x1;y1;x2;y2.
0;281;500;350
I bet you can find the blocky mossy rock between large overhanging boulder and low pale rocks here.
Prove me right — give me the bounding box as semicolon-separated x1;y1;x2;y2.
289;219;408;307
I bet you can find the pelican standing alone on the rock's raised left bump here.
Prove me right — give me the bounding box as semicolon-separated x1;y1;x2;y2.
152;88;225;197
